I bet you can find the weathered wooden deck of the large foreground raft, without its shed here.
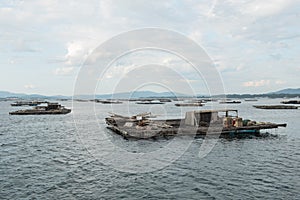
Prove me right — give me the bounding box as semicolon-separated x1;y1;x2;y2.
106;118;286;139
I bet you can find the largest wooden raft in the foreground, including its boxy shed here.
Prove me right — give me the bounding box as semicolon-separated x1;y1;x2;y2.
105;109;287;139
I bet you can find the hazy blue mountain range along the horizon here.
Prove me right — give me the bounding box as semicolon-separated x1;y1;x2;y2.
0;88;300;99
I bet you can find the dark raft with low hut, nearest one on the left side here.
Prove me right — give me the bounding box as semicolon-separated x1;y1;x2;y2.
9;102;71;115
